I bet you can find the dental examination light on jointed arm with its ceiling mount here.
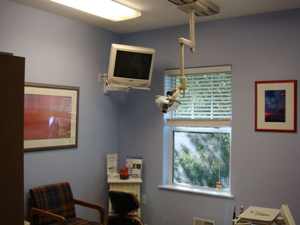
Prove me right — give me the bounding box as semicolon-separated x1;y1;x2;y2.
155;0;220;113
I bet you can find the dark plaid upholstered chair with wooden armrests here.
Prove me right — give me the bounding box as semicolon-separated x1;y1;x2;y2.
29;183;106;225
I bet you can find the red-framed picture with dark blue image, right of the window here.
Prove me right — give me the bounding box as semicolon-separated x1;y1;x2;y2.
255;80;297;132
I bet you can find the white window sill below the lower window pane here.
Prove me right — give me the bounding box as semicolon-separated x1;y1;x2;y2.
158;184;234;199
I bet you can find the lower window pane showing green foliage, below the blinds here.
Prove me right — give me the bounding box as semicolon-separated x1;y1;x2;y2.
173;128;231;188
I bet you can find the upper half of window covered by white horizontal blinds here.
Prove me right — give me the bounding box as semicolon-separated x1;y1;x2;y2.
164;66;232;125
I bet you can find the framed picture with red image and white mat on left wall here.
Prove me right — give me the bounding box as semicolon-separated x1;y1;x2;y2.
24;83;79;152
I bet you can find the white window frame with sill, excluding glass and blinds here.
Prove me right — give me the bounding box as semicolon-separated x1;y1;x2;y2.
159;65;233;198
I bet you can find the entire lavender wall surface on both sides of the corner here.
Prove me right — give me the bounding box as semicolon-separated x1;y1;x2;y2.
0;0;300;225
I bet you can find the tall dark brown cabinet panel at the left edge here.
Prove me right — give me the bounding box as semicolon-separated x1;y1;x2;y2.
0;56;25;225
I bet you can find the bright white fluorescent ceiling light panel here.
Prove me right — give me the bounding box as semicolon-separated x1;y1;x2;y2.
50;0;141;22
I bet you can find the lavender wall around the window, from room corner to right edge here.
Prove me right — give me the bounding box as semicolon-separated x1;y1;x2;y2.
120;10;300;225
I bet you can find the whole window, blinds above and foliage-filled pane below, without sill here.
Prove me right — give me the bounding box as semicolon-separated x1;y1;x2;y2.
165;66;232;192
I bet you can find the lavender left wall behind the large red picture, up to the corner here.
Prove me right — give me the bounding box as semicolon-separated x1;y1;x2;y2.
0;0;119;218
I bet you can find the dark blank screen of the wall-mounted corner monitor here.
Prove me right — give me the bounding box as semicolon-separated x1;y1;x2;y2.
114;50;152;80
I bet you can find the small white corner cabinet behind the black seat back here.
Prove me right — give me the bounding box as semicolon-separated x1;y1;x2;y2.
107;179;143;216
